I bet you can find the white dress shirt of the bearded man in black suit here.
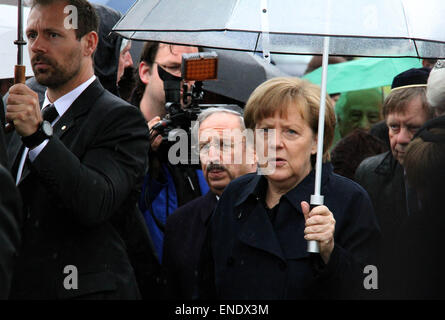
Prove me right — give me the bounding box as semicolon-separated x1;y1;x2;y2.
16;75;96;185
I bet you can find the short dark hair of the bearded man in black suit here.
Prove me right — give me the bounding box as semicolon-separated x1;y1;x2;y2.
31;0;99;40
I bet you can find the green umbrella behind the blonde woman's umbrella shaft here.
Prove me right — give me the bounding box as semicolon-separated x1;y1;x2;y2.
303;58;422;94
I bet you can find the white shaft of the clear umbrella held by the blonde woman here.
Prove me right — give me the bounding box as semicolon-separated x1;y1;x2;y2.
307;37;329;253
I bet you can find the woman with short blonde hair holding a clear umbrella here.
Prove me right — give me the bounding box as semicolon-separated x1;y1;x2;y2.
201;78;379;300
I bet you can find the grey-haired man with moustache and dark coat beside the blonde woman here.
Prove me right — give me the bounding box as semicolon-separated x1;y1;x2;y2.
162;107;256;299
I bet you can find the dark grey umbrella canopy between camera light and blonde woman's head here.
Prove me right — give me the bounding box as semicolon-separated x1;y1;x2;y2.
203;49;288;103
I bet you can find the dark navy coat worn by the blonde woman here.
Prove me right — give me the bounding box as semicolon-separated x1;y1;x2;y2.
200;164;380;300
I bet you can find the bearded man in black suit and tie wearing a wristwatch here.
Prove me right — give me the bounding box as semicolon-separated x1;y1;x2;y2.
6;0;149;299
